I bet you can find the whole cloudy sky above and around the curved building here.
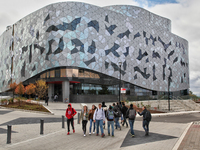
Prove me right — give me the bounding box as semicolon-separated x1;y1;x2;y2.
0;0;200;96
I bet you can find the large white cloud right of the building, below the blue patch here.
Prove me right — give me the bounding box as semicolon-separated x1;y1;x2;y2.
146;0;200;94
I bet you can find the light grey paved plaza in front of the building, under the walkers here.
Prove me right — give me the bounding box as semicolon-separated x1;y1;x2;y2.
0;103;200;150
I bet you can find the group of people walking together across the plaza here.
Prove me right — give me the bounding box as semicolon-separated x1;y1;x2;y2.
66;102;151;137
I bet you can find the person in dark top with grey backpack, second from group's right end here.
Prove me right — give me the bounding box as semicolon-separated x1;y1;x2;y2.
126;104;136;137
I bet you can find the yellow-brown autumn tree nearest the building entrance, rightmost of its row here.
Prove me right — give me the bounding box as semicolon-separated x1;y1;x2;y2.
35;80;48;99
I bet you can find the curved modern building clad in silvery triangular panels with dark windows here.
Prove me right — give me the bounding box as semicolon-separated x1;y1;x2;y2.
0;2;189;102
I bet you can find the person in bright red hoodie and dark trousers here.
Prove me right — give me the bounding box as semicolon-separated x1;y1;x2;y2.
65;103;77;135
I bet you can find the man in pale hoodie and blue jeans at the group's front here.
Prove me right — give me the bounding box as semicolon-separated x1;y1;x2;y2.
93;104;105;137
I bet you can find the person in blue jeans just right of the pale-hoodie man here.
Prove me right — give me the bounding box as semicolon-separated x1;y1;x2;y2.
106;105;114;137
